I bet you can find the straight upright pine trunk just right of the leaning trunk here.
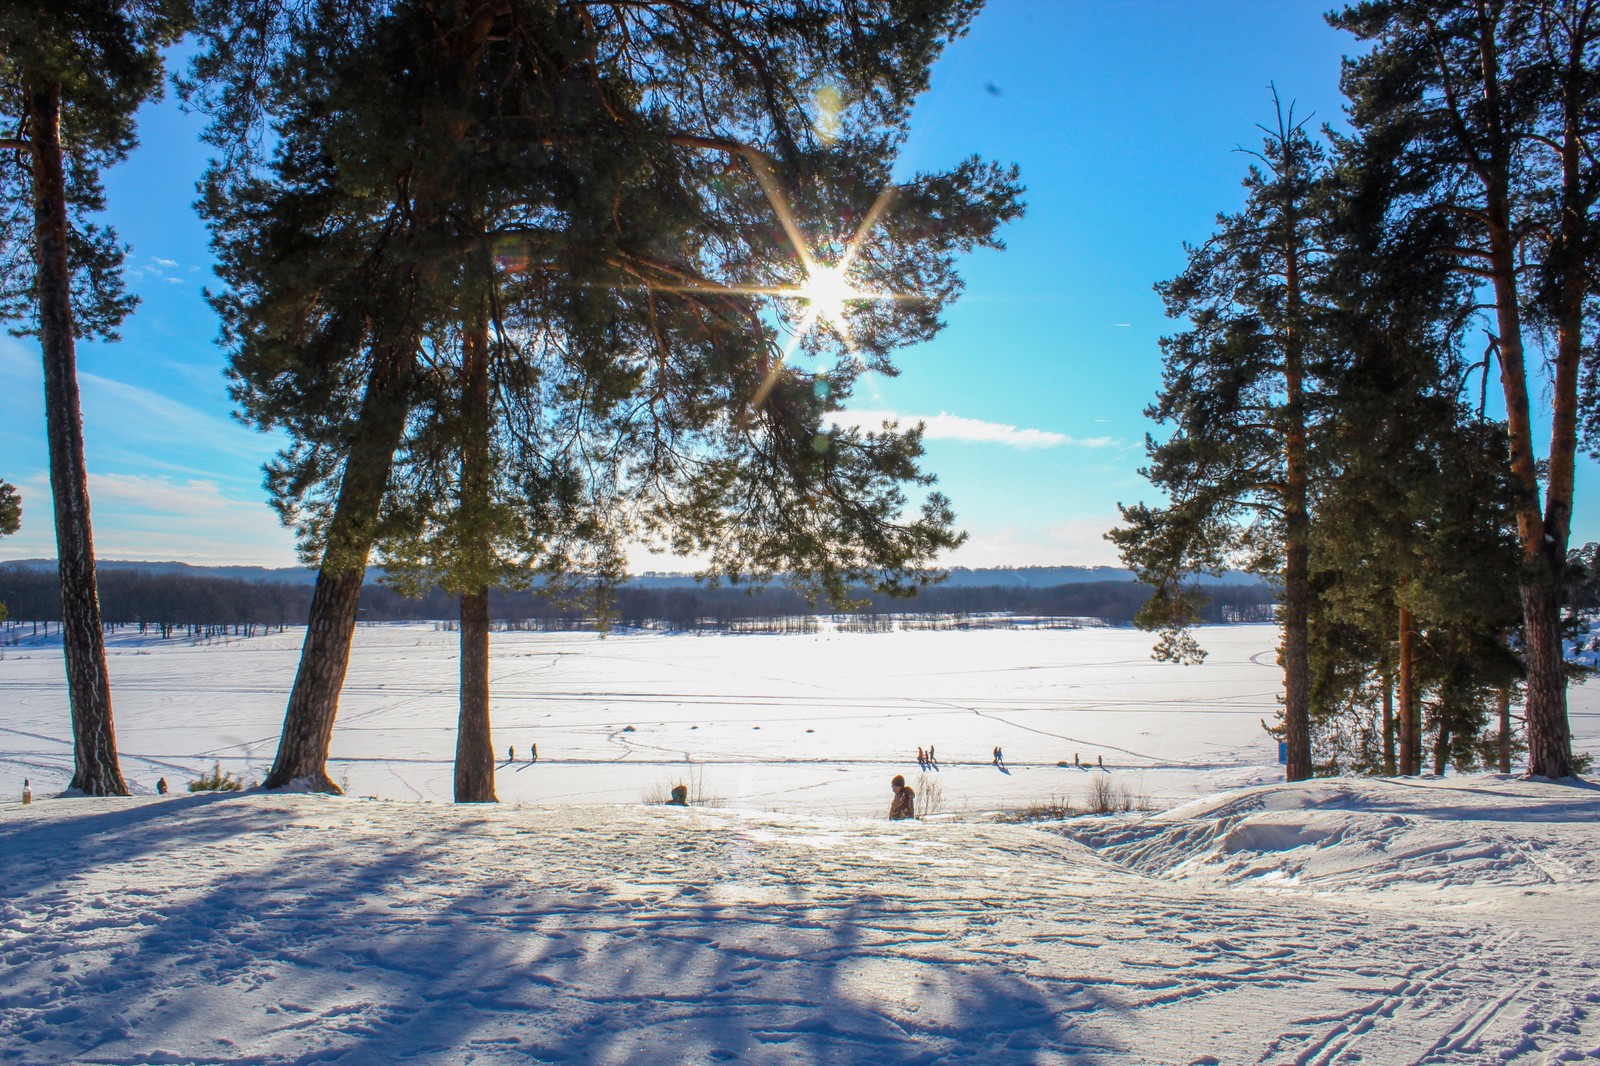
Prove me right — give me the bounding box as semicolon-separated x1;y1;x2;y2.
456;314;496;804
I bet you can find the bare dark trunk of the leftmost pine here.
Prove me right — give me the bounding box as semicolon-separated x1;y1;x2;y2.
26;85;128;795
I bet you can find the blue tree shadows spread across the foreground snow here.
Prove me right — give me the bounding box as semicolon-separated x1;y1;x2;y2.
0;797;1125;1066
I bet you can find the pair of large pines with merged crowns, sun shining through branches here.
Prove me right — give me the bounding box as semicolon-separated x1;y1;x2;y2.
192;0;1019;787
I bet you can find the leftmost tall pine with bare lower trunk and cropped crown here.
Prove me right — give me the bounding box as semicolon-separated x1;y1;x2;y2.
0;0;186;795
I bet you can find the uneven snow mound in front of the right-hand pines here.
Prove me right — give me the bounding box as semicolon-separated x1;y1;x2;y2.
1058;775;1600;908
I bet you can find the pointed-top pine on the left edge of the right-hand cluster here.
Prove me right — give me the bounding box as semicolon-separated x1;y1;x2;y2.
1109;106;1326;781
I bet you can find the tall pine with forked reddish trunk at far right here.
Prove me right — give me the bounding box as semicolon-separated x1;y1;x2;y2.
1330;0;1600;778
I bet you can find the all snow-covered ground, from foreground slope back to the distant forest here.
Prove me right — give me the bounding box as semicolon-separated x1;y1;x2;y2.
0;626;1600;1066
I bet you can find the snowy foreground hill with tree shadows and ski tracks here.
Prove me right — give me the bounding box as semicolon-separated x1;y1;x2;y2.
0;776;1600;1066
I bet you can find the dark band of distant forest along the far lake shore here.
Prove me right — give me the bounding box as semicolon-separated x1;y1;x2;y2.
0;567;1274;637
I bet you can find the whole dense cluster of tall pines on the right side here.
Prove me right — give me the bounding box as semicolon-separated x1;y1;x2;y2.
1110;0;1600;779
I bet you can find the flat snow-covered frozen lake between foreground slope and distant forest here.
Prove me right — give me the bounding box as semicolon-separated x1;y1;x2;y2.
0;624;1600;815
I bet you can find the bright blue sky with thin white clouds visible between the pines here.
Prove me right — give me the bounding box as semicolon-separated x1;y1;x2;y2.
0;0;1600;567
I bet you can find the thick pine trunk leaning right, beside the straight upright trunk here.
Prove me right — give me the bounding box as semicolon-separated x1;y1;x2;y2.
262;338;416;794
